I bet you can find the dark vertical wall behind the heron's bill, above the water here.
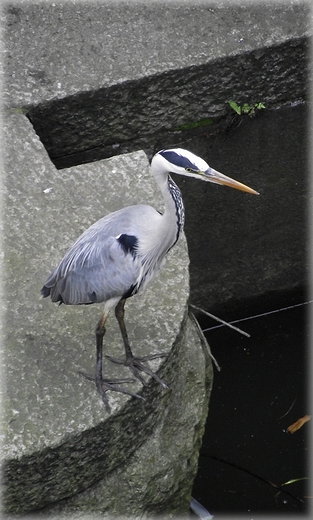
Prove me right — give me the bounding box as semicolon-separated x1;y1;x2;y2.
176;103;312;312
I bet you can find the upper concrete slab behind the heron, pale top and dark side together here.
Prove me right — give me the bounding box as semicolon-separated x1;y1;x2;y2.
3;2;310;166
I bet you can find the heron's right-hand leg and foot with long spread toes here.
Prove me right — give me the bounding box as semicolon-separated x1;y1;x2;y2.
106;299;168;388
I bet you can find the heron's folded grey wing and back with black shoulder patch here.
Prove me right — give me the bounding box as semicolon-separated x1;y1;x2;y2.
41;205;162;305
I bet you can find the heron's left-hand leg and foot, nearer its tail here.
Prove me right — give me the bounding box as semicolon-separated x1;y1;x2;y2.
79;313;143;413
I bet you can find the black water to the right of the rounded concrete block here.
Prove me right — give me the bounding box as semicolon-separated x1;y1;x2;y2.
193;292;313;518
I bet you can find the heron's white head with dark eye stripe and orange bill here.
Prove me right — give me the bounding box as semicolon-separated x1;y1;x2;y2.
151;148;258;195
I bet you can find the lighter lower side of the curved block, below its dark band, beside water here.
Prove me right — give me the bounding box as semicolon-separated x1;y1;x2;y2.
22;314;212;520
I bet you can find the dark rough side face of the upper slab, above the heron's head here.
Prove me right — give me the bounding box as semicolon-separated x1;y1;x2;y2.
28;35;309;166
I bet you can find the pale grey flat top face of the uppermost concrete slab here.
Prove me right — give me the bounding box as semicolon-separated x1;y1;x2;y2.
2;0;311;107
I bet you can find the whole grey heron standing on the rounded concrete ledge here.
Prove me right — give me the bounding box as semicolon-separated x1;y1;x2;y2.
41;148;257;411
